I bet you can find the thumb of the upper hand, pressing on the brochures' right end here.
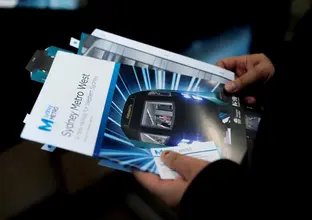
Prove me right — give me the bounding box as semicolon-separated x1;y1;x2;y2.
225;66;264;93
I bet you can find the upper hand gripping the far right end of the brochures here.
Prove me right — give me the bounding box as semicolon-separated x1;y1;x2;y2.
217;54;275;104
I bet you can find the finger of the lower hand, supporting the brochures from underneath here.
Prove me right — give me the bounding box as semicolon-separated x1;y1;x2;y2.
133;170;161;192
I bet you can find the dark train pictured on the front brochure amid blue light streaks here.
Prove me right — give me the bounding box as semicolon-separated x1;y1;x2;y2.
121;90;227;148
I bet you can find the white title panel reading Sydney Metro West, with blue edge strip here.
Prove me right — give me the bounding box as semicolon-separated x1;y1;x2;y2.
21;52;119;156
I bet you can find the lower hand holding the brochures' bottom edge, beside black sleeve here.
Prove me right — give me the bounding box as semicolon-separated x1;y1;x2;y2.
134;151;208;206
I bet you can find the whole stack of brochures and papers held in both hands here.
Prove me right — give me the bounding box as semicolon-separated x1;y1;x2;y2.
21;29;260;179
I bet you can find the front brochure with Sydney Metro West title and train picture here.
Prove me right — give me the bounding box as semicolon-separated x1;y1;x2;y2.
21;52;259;178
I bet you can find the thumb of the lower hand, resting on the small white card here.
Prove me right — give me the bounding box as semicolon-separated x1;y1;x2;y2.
161;151;208;181
